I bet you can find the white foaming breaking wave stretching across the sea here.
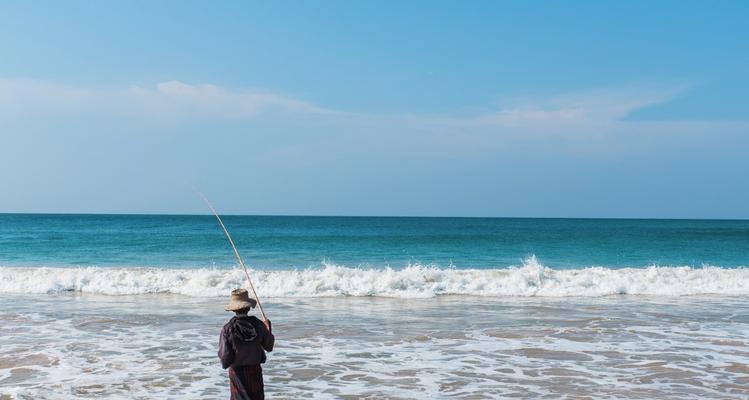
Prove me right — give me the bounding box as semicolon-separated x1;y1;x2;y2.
0;257;749;298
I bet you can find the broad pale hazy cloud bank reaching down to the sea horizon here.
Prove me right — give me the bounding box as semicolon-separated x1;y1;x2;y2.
0;79;749;215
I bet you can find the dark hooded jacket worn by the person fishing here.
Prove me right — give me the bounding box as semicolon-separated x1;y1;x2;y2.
218;315;275;369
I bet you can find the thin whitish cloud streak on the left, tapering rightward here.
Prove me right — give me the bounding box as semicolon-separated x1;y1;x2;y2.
0;79;332;120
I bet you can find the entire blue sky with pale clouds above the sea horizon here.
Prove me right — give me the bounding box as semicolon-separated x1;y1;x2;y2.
0;1;749;218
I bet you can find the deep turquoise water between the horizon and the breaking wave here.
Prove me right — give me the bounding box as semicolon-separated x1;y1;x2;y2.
0;214;749;270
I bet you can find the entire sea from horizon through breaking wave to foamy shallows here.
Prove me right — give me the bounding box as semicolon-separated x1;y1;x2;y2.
0;214;749;399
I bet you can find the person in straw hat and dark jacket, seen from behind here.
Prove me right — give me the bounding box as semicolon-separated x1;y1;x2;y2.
218;289;275;400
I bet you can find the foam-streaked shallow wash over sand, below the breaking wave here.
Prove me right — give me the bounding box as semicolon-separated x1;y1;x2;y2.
0;293;749;400
